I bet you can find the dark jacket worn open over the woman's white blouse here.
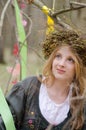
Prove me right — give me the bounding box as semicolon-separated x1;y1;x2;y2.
0;77;86;130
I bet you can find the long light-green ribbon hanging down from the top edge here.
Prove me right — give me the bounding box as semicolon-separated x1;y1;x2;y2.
15;0;27;79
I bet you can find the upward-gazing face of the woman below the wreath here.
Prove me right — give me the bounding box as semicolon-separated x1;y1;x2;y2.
52;46;75;82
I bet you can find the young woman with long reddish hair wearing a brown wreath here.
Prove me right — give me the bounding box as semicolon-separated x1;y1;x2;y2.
0;31;86;130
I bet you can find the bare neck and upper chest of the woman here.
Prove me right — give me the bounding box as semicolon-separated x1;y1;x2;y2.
47;80;70;104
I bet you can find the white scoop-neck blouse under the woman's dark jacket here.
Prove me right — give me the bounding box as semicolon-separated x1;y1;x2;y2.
39;84;71;125
